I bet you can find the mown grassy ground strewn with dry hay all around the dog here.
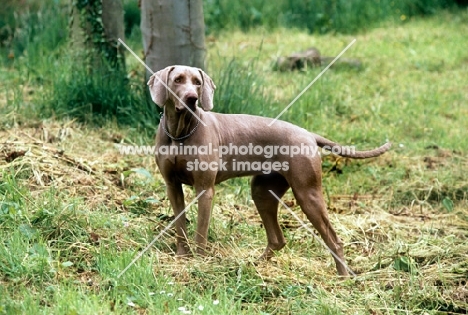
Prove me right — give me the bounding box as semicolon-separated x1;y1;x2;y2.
0;6;468;314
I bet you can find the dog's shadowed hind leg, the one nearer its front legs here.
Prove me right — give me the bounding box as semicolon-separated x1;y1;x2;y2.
251;173;289;260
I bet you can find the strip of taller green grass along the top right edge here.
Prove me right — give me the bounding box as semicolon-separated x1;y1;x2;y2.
203;0;455;34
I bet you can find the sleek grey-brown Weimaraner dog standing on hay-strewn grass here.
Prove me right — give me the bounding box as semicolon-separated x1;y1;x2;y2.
148;66;391;275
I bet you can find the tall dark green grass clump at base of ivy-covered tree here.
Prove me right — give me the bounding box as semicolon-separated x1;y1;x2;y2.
40;57;157;128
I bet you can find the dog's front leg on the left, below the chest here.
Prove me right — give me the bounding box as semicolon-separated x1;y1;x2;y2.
167;183;189;256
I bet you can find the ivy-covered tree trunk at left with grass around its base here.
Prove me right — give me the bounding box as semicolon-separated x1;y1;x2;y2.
66;0;128;121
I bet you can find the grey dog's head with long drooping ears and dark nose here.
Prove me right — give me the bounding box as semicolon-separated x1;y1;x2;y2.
148;66;216;111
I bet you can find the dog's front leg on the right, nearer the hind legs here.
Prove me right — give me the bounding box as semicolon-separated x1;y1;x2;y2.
195;186;214;255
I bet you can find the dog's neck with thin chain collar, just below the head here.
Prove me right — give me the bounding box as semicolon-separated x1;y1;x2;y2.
163;104;199;138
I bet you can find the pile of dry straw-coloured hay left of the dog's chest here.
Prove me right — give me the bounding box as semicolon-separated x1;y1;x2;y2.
0;121;153;206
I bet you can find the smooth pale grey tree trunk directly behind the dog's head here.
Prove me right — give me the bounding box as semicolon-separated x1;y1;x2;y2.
140;0;205;77
